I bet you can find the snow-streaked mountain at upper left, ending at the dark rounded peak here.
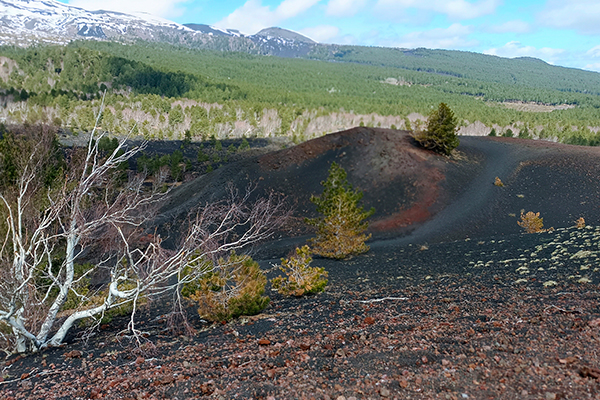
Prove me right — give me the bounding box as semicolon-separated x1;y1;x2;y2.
0;0;317;57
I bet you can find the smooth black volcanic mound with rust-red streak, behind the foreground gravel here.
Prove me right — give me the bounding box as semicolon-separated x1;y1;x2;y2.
159;127;600;253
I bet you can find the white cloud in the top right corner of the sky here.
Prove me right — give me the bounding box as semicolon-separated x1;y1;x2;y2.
538;0;600;35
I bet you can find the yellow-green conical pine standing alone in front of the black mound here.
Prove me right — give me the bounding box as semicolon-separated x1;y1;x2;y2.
306;162;375;259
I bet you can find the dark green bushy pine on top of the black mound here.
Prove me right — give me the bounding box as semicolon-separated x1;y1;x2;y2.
413;103;459;155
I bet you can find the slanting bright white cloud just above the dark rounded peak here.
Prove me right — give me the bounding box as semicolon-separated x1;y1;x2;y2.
215;0;320;33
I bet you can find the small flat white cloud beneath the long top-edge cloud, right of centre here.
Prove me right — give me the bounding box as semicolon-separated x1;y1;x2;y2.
396;23;477;49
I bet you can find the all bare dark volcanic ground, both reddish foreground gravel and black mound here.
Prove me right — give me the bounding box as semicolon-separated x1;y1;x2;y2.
0;128;600;400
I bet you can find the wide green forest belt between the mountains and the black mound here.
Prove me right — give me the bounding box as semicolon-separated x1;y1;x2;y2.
0;41;600;145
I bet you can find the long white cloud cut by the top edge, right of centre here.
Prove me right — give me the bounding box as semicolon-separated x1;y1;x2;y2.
375;0;500;20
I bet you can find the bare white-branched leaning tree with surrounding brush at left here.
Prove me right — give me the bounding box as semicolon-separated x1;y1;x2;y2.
0;104;287;352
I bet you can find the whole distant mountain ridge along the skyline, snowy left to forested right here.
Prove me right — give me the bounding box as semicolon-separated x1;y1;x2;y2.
0;0;600;95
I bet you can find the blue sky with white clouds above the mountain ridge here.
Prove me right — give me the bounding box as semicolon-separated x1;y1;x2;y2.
61;0;600;72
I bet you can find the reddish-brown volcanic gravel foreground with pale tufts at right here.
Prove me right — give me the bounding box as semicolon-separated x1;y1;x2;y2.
0;227;600;400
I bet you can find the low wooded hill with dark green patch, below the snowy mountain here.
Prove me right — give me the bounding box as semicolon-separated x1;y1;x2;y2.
2;46;244;105
